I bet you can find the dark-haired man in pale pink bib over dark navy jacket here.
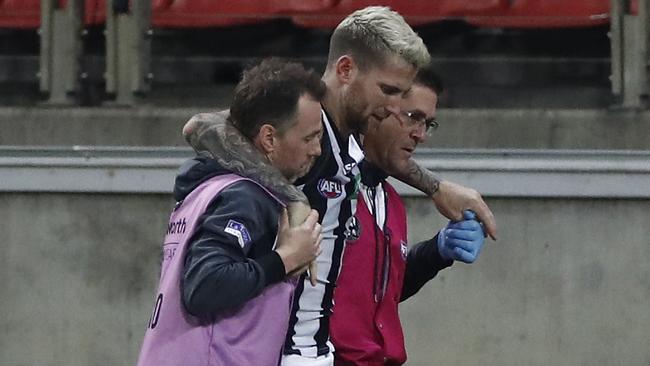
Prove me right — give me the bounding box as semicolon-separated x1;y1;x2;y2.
138;59;325;366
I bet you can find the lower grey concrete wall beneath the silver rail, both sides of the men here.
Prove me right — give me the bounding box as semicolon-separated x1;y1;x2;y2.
0;193;650;366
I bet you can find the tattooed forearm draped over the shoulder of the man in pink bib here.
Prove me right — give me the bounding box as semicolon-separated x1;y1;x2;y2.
186;111;308;203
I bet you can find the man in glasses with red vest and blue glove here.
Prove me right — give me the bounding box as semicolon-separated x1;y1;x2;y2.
330;66;484;366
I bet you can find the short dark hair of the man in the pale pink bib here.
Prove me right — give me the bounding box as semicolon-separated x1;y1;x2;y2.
230;57;326;140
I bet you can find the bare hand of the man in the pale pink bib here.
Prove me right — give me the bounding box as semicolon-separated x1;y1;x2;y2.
275;209;321;276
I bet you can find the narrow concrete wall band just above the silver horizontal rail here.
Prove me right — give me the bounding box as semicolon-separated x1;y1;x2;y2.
0;106;650;150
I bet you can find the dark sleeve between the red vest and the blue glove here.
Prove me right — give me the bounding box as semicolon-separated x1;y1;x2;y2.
400;235;453;302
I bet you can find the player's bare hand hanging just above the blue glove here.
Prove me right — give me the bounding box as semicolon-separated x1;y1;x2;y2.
433;181;497;240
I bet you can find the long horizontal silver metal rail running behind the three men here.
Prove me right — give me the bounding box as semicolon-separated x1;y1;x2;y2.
0;146;650;199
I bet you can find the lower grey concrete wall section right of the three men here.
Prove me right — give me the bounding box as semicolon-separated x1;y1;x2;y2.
402;199;650;366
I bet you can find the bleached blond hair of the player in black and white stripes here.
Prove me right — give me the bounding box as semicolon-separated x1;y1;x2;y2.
327;6;431;69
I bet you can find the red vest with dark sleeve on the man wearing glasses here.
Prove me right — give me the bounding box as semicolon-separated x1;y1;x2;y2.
330;163;451;366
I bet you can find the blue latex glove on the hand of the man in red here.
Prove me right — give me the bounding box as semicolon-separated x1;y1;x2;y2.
438;210;485;263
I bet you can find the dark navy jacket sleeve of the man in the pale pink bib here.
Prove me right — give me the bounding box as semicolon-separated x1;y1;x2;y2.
181;181;285;317
